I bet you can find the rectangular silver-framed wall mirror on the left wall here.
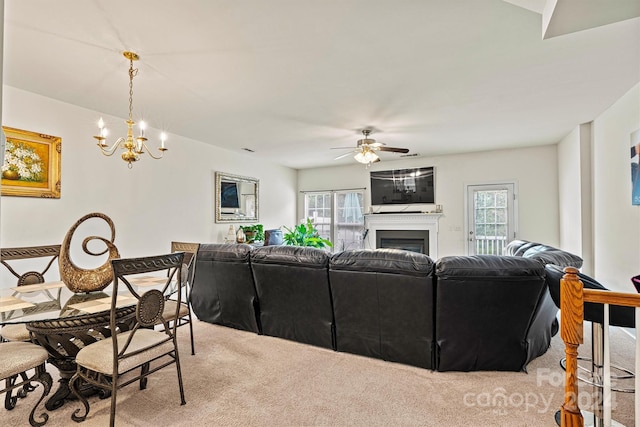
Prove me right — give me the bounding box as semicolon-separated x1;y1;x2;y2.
215;172;259;222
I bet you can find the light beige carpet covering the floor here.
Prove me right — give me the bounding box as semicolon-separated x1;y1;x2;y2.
0;321;634;427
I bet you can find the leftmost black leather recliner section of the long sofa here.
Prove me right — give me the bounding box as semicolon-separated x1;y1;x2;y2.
191;243;261;333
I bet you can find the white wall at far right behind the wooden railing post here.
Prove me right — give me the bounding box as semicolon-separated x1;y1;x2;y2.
593;83;640;292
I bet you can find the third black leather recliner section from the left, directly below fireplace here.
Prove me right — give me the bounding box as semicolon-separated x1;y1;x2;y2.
329;249;434;369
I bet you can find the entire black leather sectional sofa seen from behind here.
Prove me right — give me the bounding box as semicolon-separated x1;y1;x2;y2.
191;241;582;371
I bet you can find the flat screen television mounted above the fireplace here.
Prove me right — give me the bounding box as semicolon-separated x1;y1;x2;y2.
370;166;435;205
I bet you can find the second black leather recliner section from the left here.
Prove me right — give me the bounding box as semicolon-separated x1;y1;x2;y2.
251;246;335;350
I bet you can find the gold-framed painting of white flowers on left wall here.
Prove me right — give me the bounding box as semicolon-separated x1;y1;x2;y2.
2;126;62;199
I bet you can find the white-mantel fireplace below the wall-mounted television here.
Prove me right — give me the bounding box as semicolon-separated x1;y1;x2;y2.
364;213;443;259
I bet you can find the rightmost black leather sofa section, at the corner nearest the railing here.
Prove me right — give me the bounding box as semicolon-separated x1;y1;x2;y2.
435;255;558;371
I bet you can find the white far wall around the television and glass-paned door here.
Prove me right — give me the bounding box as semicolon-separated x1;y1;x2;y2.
298;145;559;257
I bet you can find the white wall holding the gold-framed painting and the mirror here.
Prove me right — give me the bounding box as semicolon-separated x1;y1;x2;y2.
0;86;296;290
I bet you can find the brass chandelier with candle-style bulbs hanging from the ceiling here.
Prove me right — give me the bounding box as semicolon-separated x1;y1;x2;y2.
94;52;167;169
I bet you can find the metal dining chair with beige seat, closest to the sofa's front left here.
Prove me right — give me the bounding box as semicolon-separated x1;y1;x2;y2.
69;252;186;426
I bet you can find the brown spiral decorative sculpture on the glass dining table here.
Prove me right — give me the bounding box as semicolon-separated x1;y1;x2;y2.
58;212;120;293
